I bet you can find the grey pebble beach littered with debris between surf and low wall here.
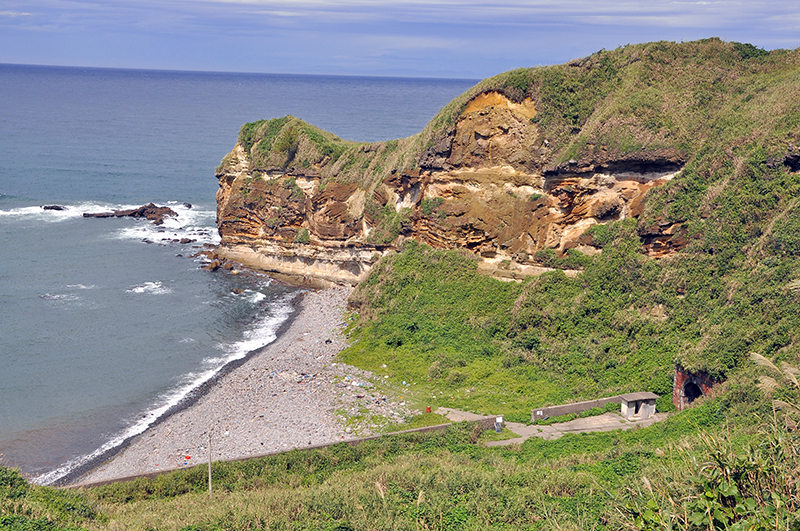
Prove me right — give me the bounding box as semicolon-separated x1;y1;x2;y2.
74;288;411;483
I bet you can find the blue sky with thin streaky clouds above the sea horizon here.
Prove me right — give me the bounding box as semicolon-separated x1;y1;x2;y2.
0;0;800;79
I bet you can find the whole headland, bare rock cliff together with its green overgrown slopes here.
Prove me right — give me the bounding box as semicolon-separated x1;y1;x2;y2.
217;39;800;394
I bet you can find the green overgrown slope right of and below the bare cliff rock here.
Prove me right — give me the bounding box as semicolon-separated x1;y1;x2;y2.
344;40;800;420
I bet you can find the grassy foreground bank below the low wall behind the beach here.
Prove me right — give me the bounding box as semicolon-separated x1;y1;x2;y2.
0;400;800;531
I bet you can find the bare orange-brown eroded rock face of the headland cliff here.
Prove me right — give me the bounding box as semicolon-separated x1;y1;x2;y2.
217;92;683;285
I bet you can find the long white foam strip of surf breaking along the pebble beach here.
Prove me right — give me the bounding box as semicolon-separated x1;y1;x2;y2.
33;293;297;485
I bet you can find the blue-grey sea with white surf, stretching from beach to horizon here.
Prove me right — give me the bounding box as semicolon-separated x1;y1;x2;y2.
0;65;476;483
